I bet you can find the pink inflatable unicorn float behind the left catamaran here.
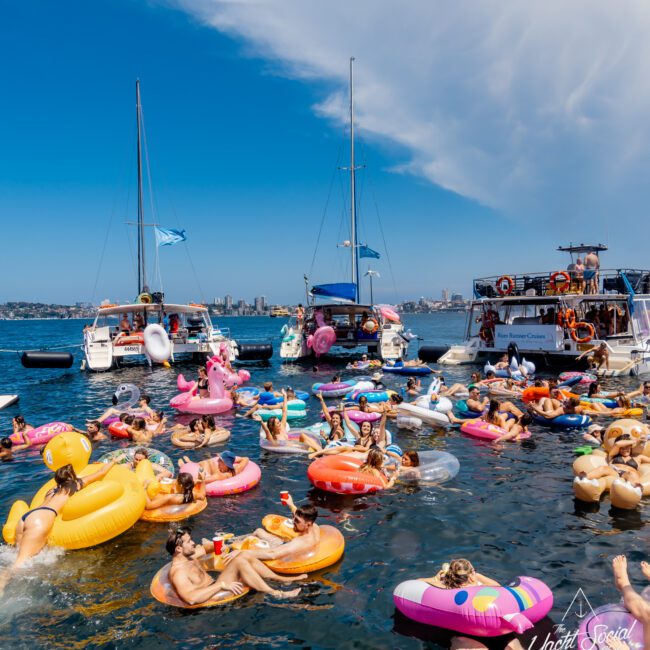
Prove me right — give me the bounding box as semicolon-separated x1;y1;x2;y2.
169;350;251;415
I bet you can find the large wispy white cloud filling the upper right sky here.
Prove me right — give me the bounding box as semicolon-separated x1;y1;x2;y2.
170;0;650;218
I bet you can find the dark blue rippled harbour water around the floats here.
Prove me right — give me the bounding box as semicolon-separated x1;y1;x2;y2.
0;314;650;649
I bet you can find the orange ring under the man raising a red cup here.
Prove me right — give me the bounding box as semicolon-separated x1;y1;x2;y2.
262;515;345;575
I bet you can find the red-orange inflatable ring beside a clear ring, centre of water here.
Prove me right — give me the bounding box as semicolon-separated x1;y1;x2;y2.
307;454;386;494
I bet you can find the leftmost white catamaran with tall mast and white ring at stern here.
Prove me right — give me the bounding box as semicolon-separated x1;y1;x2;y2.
83;80;273;371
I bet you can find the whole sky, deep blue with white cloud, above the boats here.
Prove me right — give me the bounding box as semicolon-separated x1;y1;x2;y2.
0;0;650;302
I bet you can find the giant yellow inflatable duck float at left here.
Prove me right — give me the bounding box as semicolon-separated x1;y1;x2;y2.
2;431;145;549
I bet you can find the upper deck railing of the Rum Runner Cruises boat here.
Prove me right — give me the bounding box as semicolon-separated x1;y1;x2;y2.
473;269;650;299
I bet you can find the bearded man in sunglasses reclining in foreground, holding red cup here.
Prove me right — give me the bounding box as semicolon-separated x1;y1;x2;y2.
165;527;306;605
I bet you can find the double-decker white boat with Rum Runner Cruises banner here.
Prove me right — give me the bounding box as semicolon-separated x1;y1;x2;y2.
426;244;650;376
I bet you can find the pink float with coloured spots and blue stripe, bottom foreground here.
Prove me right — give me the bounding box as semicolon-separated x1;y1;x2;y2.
393;576;553;637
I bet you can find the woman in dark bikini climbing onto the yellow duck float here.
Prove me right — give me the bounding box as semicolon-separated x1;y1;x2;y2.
13;461;115;569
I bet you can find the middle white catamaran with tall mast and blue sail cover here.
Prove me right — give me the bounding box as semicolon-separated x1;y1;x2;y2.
280;58;411;361
